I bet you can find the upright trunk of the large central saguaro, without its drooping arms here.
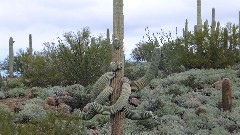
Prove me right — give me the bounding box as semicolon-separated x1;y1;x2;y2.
111;0;124;135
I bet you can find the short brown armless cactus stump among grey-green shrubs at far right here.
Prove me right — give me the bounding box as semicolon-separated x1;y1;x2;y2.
222;78;232;111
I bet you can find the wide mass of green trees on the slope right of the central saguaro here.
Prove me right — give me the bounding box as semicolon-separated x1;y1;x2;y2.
131;22;240;71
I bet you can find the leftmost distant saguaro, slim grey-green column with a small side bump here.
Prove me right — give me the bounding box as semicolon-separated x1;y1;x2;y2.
9;37;14;78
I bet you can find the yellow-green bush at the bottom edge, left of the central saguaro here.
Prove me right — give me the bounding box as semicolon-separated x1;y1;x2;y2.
15;112;86;135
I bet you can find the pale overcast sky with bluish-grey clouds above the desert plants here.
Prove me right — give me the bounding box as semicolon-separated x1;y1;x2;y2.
0;0;240;61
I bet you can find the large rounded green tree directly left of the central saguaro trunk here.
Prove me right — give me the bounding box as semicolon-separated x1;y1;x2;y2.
55;28;111;86
